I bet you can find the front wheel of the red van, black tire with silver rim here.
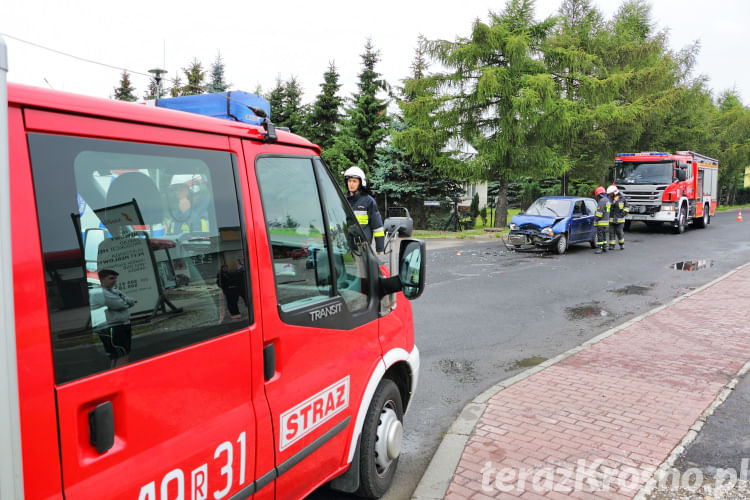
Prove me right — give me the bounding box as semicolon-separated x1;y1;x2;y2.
357;379;404;498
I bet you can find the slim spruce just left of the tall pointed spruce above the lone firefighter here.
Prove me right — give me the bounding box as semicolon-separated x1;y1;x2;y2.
305;63;343;151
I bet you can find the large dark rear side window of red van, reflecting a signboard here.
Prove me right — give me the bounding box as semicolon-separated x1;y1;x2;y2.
29;134;252;383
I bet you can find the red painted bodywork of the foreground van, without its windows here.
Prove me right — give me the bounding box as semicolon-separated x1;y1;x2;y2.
9;85;418;500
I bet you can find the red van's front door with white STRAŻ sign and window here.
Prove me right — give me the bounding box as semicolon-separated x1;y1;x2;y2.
246;152;381;498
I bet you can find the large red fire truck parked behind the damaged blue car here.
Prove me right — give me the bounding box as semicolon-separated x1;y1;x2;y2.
614;151;719;233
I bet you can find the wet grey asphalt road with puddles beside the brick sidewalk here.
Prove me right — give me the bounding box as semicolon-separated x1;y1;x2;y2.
310;212;750;500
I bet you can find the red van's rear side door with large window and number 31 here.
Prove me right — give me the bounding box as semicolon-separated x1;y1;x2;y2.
26;111;266;500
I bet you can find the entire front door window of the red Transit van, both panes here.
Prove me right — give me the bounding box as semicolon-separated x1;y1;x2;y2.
256;157;369;312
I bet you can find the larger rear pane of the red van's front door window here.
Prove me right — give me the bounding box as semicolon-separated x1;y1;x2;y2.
255;157;333;312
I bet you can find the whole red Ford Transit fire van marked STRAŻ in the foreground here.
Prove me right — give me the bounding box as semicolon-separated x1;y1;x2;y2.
0;40;425;500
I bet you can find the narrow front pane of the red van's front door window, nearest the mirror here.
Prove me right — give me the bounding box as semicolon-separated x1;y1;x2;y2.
315;163;369;312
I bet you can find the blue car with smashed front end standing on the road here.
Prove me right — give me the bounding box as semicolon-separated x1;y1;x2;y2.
507;196;596;254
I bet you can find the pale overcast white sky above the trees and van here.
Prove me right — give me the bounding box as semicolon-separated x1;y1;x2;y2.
0;0;750;105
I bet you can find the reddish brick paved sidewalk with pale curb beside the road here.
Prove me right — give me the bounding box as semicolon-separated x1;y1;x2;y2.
413;265;750;500
